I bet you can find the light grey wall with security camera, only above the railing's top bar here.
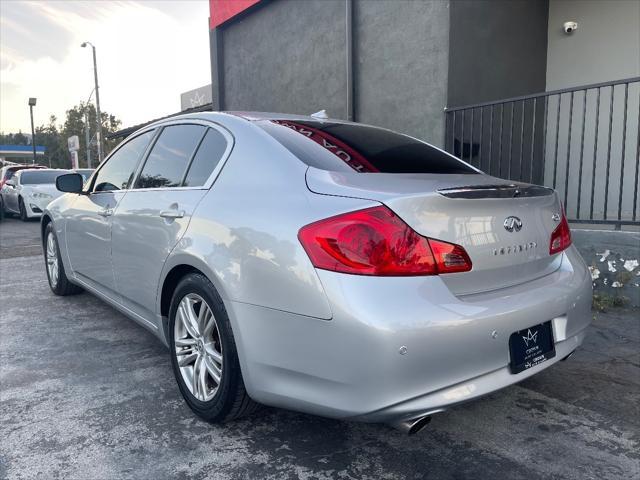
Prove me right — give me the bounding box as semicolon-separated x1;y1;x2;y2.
547;0;640;90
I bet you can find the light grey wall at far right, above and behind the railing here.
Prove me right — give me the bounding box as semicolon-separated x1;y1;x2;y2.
545;0;640;220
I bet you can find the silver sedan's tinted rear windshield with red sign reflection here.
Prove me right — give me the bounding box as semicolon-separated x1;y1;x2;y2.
256;120;478;174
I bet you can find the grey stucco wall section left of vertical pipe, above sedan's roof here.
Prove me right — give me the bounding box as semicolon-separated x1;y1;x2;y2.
222;0;347;118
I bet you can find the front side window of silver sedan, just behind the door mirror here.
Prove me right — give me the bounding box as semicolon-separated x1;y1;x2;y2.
93;130;154;192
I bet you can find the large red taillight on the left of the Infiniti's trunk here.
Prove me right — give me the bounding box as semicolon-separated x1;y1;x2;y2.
298;206;471;276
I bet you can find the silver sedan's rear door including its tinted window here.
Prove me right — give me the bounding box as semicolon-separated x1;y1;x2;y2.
112;123;232;319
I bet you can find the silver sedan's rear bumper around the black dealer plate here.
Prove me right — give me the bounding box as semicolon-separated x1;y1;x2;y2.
230;247;591;423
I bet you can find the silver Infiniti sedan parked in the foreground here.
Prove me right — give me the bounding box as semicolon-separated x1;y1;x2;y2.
42;112;591;432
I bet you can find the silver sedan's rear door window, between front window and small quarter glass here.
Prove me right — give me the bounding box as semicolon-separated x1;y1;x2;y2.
135;125;206;188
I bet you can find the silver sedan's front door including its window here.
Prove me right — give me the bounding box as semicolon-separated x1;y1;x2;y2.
65;130;155;297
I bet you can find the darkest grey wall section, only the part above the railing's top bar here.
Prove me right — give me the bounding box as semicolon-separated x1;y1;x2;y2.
448;0;548;106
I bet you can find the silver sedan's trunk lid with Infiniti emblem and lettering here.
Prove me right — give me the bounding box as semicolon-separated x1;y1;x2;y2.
307;167;562;295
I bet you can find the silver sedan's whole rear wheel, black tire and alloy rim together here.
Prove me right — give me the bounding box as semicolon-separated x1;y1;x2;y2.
168;273;259;423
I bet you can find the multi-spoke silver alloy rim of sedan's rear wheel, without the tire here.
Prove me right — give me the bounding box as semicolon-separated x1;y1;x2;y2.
173;293;222;402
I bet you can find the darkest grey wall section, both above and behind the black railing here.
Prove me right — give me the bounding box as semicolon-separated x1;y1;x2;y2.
445;0;548;183
